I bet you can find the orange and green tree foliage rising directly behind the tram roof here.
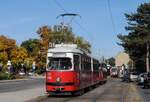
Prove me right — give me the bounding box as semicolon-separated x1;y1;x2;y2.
37;24;91;53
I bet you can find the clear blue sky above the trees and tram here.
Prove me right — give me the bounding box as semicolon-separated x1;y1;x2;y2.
0;0;150;58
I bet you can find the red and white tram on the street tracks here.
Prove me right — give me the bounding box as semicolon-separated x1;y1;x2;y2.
46;44;104;94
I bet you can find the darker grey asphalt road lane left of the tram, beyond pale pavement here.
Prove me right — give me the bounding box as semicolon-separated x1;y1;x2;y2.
0;78;44;93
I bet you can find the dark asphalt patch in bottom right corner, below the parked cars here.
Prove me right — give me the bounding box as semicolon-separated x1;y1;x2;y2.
138;86;150;102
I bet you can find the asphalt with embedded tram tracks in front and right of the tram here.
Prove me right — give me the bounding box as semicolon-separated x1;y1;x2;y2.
30;79;128;102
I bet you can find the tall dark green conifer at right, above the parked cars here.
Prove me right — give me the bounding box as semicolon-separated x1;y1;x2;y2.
118;3;150;71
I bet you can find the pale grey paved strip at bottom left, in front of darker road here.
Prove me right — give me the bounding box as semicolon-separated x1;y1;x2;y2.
0;87;46;102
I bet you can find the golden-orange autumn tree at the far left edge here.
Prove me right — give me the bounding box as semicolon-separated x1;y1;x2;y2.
0;35;28;70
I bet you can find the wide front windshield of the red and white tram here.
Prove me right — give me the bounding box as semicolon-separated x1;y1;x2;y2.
48;57;72;70
